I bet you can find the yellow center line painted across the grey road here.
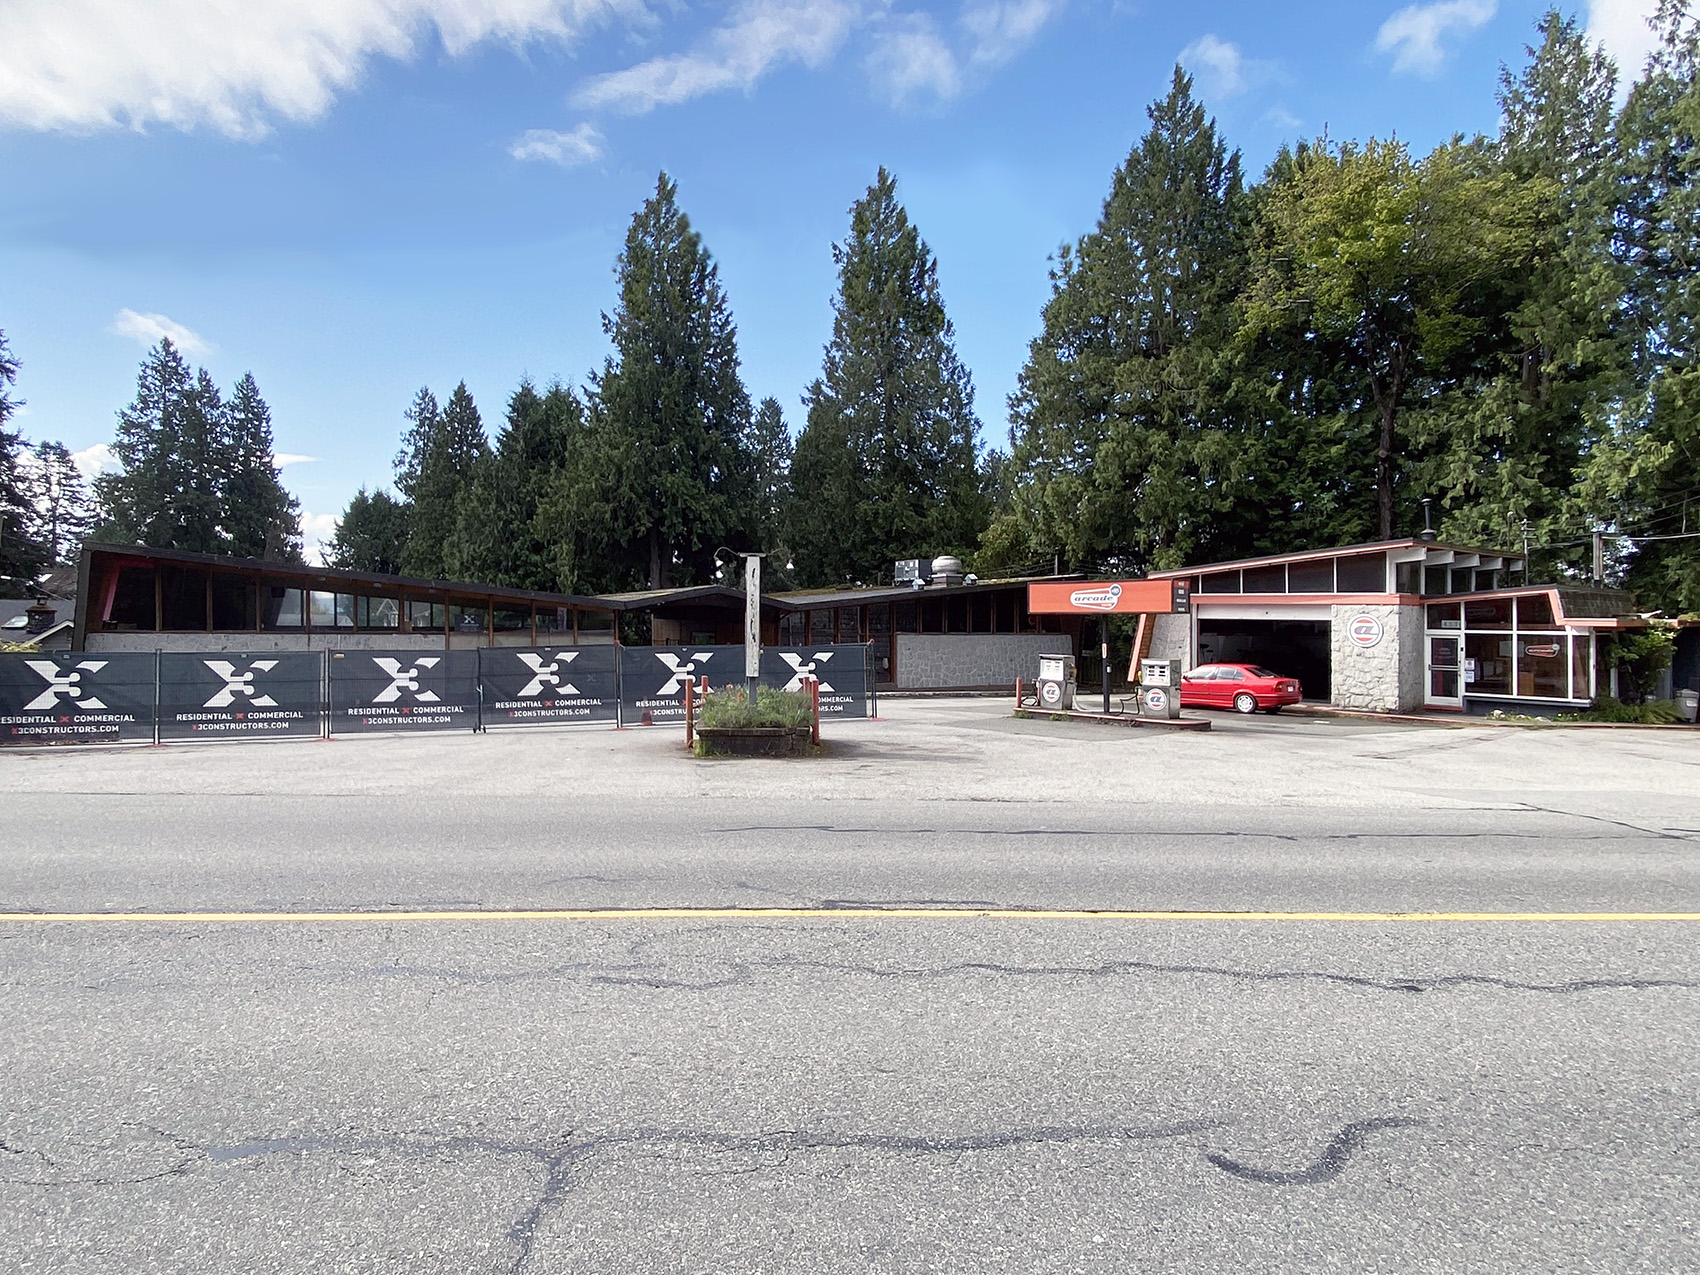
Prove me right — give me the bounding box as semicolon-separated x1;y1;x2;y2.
0;908;1700;925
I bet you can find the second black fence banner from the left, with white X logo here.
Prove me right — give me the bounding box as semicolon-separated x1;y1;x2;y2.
160;651;325;740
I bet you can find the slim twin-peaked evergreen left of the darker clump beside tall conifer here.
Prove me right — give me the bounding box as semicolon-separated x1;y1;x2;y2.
396;381;490;580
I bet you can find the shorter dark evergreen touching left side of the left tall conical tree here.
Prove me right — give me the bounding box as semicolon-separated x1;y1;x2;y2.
447;381;585;590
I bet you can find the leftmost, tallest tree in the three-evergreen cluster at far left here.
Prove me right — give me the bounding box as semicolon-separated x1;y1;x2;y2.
95;337;230;553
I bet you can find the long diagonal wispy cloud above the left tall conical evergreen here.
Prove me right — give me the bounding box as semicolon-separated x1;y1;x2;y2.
573;0;857;116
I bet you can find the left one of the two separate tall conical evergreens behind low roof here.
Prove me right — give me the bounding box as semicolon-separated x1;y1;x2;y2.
539;173;755;588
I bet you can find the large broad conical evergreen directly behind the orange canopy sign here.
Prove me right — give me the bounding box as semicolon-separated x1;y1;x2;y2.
995;77;1260;571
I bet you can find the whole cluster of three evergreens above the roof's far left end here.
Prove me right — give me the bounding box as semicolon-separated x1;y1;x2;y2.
95;338;301;559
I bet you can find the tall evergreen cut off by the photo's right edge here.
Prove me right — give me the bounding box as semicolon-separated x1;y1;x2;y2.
1581;0;1700;612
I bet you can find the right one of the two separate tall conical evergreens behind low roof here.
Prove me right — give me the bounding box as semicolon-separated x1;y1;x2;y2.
787;168;989;585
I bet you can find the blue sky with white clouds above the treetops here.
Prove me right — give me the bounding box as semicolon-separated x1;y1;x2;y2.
0;0;1651;557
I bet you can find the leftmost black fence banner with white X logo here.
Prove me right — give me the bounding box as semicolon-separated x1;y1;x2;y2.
0;651;155;743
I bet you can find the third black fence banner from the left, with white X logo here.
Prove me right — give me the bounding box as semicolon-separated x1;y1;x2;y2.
330;649;479;734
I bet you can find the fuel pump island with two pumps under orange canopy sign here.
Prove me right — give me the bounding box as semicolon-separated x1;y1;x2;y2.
1027;580;1209;729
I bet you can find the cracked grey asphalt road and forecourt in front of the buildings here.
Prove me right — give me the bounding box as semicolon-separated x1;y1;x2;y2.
0;702;1700;1275
